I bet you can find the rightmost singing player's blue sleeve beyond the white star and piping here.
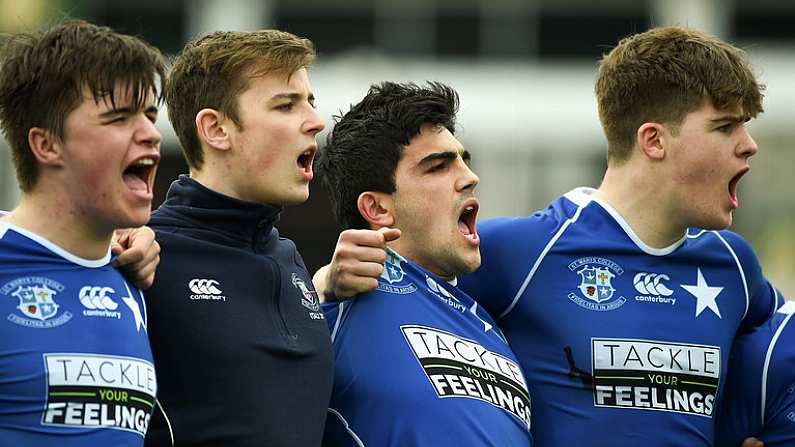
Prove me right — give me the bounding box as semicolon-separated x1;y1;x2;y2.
720;231;784;334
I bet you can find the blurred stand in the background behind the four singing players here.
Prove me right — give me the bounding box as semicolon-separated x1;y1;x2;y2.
0;0;795;297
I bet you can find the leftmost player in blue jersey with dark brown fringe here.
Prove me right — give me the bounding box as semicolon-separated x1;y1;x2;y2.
0;21;165;446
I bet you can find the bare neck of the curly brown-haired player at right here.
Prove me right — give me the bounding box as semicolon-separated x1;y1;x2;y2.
595;161;687;248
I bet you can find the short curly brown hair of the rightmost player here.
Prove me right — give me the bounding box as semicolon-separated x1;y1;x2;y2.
596;26;764;162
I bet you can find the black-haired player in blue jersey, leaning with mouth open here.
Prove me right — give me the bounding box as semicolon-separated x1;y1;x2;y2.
319;82;532;447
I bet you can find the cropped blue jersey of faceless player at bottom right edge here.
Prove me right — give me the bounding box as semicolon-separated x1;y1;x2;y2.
715;302;795;447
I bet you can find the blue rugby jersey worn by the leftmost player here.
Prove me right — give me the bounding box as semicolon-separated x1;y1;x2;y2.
0;223;157;447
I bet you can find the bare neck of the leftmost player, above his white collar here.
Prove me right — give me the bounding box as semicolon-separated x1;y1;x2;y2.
2;191;113;260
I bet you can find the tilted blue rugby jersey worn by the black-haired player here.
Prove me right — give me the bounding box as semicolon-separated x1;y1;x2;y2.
324;251;532;447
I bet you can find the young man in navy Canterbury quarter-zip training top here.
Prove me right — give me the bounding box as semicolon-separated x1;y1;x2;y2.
147;30;333;447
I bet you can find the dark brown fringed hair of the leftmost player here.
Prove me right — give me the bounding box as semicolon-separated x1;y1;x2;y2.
0;21;165;192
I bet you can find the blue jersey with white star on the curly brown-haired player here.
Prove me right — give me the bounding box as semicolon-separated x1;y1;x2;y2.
461;188;776;447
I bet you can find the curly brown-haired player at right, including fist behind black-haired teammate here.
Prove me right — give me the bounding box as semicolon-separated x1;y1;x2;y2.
316;27;779;447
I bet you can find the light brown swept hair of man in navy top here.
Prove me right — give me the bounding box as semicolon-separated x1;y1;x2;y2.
166;30;315;169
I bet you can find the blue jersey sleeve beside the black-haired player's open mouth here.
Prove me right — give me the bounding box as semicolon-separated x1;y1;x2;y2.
459;206;562;319
